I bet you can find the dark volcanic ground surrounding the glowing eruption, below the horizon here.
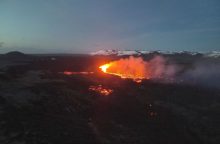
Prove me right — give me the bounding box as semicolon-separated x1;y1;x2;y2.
0;52;220;144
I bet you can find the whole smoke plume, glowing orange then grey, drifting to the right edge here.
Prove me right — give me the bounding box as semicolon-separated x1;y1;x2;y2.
102;56;220;88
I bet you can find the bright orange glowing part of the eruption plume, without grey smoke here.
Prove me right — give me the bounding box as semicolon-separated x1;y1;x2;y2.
99;56;150;82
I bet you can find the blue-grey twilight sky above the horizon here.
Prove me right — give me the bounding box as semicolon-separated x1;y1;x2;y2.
0;0;220;53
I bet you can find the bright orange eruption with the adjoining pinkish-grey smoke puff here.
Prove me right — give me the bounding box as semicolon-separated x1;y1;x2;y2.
99;56;177;82
